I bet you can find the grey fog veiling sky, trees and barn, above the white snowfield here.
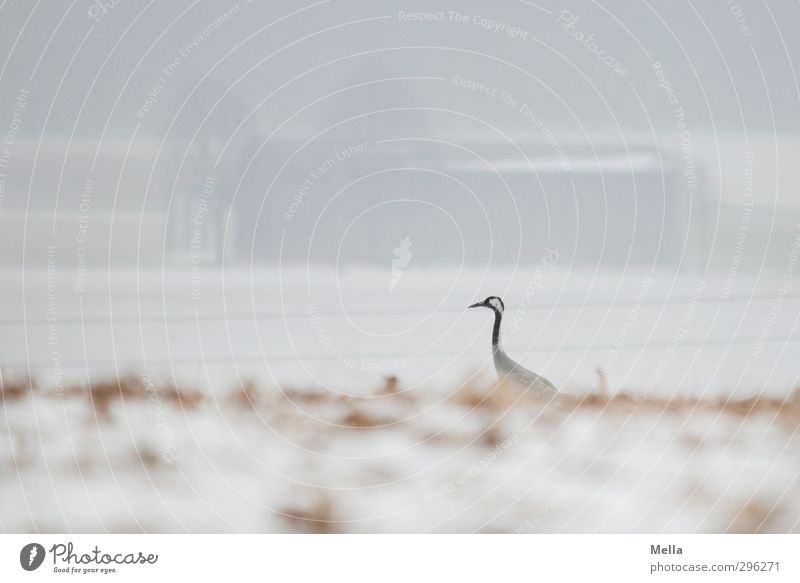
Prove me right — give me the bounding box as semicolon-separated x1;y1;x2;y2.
0;2;800;273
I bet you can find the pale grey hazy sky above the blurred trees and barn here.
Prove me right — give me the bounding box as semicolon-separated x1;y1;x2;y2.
0;0;800;137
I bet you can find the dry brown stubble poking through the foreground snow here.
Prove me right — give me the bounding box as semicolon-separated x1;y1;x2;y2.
0;376;800;533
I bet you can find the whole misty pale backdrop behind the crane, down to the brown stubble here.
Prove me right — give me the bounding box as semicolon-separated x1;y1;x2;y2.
0;2;800;394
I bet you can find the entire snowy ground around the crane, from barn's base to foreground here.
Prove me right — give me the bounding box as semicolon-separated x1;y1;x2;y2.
0;269;800;532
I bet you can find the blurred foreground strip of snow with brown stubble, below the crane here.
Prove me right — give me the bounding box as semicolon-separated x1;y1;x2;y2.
0;374;800;532
